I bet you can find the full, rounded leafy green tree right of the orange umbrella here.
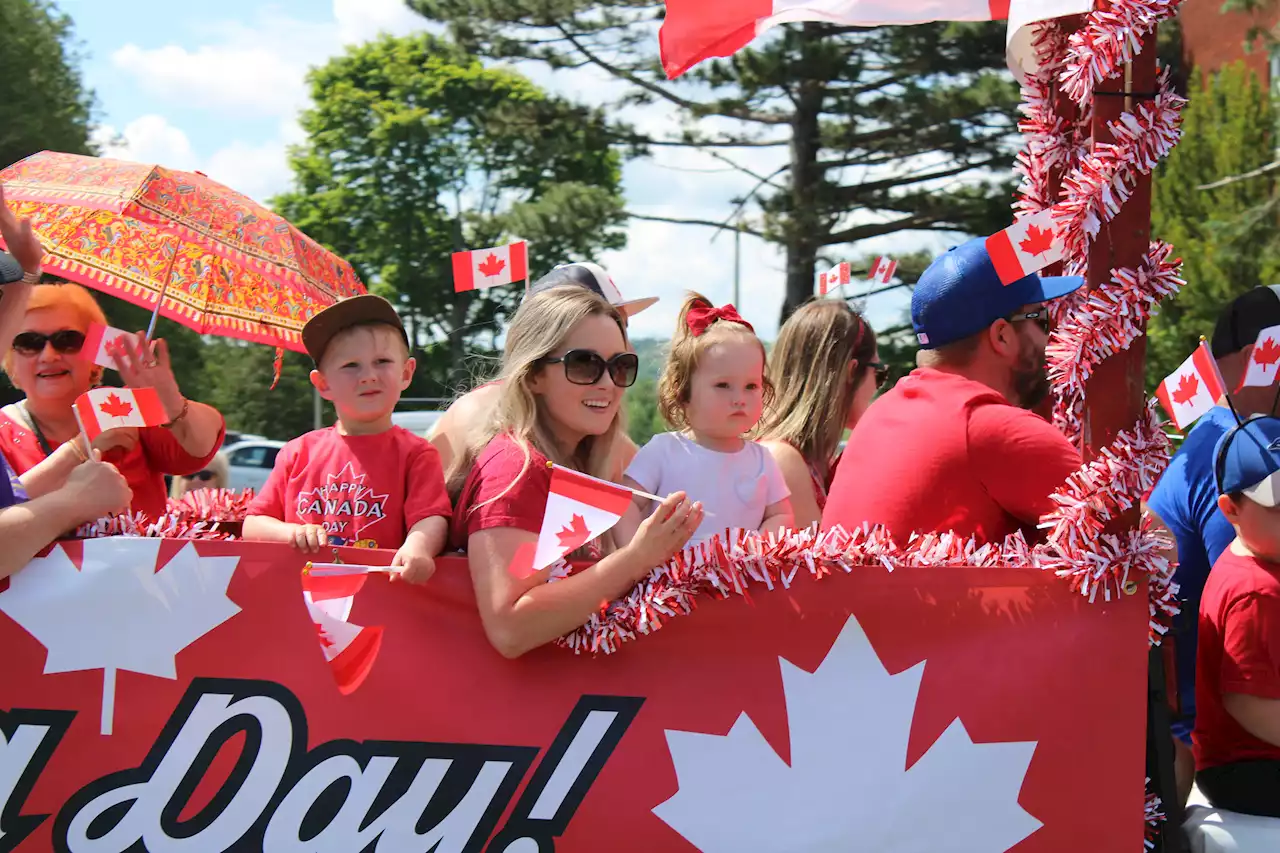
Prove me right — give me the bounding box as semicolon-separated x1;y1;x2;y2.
274;35;625;396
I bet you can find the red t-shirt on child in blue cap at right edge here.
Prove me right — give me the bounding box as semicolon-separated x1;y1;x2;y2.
1192;548;1280;770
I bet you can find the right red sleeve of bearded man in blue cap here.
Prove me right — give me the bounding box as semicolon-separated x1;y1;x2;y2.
968;403;1083;524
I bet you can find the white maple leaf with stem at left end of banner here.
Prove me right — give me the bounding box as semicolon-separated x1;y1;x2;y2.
0;537;239;734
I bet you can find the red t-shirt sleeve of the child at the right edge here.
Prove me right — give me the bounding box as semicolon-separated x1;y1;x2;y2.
1219;593;1280;699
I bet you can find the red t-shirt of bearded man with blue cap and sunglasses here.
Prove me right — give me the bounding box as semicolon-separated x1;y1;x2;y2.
822;368;1082;543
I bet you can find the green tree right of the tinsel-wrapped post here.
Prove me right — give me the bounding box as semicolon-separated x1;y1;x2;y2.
1147;63;1280;388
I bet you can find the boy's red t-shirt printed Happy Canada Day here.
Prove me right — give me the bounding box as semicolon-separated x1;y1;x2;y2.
248;427;449;548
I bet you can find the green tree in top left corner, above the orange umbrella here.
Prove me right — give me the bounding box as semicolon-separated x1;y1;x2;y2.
0;0;93;168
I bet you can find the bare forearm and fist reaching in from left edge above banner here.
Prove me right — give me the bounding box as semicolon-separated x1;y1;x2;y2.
0;450;133;578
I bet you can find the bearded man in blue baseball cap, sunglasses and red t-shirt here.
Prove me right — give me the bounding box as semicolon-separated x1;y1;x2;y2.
822;238;1083;543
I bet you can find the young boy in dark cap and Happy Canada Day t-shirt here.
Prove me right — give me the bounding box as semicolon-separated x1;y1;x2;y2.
244;295;451;583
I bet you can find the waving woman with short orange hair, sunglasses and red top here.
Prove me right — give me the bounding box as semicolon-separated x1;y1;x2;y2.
0;284;224;516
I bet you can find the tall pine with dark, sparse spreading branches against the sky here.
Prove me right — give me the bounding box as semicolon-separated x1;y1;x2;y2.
410;0;1018;319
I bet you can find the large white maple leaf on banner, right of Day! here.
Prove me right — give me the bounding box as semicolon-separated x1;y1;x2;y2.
653;616;1041;853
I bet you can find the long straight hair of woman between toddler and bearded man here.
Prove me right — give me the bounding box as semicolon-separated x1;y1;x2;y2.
756;300;876;467
